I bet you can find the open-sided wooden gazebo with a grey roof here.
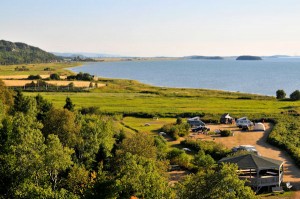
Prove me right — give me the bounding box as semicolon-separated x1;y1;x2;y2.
218;154;283;193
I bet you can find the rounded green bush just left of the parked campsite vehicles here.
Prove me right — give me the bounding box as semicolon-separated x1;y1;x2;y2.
161;123;190;140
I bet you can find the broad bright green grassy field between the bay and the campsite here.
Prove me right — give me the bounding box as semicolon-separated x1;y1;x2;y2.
26;87;300;118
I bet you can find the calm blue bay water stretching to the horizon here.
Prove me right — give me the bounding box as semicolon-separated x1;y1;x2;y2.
71;58;300;95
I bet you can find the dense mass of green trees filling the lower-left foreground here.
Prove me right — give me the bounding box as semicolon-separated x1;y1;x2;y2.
0;82;255;199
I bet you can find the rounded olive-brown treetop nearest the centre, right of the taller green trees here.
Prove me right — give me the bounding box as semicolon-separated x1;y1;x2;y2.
119;133;156;159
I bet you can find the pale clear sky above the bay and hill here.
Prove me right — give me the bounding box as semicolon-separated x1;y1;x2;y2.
0;0;300;56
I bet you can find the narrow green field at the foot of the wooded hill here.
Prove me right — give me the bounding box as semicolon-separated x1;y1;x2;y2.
0;62;81;76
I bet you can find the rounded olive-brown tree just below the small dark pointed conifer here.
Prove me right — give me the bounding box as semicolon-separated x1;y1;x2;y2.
42;108;80;148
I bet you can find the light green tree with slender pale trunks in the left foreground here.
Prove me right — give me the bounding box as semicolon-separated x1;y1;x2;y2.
45;134;74;190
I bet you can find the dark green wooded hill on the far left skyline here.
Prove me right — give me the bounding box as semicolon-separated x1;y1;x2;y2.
0;40;60;65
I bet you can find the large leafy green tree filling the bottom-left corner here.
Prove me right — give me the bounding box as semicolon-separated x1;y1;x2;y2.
0;112;46;196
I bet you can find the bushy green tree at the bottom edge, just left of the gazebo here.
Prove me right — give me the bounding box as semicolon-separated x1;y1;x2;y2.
176;164;256;199
